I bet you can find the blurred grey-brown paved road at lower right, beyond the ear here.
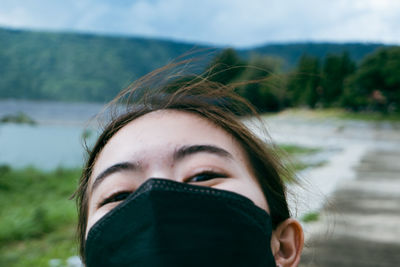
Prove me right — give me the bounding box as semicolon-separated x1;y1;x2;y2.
300;150;400;267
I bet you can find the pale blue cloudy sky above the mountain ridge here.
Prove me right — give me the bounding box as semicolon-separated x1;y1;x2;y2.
0;0;400;47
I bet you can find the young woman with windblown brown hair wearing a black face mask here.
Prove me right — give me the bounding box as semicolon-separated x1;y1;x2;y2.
76;66;304;267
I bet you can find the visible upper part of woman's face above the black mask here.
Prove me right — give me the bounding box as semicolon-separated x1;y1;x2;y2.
86;110;269;234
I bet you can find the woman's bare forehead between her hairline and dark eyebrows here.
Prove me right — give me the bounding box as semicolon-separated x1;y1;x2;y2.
92;110;244;181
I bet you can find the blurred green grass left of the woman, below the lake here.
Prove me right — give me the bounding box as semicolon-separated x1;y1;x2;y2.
0;166;80;266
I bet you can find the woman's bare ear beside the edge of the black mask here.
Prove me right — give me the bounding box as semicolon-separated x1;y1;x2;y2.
271;218;304;267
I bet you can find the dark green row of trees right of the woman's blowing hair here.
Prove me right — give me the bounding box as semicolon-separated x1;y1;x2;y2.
205;47;400;113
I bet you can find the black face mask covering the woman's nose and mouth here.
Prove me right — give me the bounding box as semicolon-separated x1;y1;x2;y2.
85;178;276;267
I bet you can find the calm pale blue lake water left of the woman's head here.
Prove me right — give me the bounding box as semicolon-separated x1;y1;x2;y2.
0;100;103;170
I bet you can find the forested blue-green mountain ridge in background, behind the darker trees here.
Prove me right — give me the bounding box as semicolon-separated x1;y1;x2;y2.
0;28;390;101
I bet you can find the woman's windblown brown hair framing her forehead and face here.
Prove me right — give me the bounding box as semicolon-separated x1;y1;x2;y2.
75;62;292;262
